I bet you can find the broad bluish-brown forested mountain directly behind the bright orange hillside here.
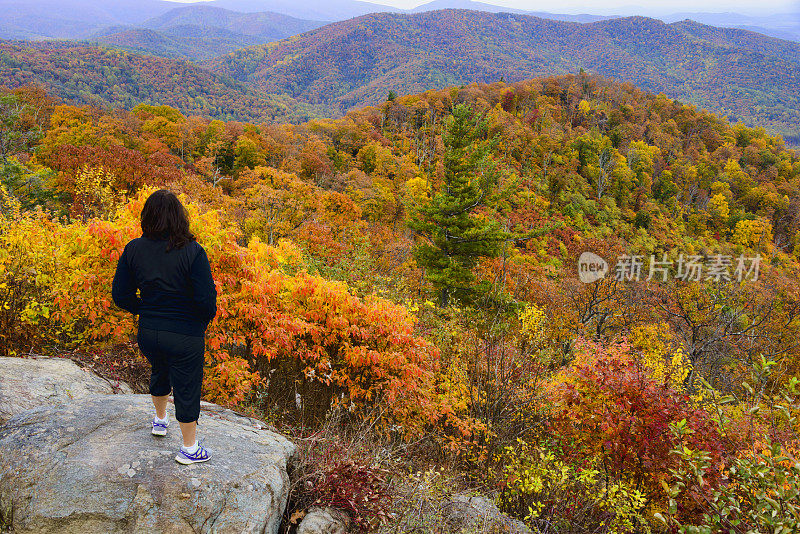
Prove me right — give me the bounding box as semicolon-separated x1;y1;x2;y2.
209;10;800;139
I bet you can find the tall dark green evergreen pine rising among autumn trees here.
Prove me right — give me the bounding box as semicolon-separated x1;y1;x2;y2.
409;104;507;307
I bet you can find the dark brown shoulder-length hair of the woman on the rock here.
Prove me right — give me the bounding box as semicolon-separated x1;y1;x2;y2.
142;189;195;250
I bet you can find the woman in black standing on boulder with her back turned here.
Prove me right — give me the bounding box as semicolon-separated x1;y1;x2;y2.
111;189;217;465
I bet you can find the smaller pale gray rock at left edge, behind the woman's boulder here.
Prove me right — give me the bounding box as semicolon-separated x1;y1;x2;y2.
0;357;132;424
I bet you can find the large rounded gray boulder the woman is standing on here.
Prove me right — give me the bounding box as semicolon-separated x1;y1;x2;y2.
0;395;294;534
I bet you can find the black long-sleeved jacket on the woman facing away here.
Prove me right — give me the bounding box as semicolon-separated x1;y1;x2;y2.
111;237;217;336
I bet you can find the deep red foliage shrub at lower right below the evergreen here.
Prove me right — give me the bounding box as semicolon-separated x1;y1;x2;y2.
549;341;724;499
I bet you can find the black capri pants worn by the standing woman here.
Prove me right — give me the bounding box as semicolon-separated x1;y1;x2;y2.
136;328;206;423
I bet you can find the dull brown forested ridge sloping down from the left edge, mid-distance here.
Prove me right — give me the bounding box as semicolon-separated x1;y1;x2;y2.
0;41;324;122
